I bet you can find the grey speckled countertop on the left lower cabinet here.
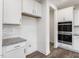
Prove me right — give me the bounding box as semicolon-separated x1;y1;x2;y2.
2;37;26;46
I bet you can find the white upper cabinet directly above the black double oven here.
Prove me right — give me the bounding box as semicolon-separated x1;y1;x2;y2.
58;7;73;21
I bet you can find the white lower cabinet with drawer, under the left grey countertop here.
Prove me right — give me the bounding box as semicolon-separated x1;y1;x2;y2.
3;42;25;58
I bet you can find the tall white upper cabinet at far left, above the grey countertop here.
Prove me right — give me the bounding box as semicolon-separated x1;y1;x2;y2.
3;0;22;24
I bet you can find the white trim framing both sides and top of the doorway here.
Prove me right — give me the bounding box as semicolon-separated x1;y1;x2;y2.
45;3;58;55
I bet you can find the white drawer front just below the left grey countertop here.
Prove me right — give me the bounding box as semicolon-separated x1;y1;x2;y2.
5;42;25;52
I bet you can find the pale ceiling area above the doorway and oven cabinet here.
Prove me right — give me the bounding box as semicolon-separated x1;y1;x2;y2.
50;0;79;8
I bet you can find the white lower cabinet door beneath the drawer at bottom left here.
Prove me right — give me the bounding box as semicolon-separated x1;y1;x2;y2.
3;47;25;58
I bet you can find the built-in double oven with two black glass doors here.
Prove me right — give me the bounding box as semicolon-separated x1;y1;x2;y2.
58;21;72;45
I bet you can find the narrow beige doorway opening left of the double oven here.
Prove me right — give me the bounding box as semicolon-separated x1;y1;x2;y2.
49;7;55;51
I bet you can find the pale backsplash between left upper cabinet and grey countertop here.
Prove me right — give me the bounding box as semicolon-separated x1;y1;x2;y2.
3;25;20;38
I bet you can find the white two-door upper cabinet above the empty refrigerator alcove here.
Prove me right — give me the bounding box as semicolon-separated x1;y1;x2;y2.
23;0;41;17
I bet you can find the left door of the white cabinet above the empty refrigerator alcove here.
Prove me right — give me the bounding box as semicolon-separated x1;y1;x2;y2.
23;0;33;14
